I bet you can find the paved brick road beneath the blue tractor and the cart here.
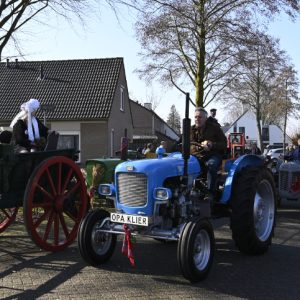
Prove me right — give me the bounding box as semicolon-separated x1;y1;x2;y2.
0;203;300;300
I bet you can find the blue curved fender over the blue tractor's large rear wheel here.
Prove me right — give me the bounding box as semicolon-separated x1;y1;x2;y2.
220;154;263;204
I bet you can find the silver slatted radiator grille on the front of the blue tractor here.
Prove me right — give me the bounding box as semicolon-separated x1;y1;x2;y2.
117;173;147;207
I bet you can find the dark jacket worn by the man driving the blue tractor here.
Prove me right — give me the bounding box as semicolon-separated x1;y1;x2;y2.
190;121;227;158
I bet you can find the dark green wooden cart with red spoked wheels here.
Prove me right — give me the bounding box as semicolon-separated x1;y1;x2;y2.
0;144;88;252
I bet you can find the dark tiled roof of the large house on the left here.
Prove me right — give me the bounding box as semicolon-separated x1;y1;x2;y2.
0;58;123;121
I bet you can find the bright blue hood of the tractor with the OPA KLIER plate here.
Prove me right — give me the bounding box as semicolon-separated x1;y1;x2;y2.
115;153;200;216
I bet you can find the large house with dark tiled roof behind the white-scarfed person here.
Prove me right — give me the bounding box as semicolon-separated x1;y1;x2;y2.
0;58;133;163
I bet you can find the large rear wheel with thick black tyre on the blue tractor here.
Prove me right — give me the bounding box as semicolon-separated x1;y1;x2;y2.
231;167;276;255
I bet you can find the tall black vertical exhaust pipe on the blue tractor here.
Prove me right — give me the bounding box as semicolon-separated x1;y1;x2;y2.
182;93;191;182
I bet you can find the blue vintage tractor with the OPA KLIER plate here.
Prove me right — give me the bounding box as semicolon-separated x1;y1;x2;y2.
78;94;276;282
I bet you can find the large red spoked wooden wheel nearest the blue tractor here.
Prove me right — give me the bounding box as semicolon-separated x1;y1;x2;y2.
23;156;88;252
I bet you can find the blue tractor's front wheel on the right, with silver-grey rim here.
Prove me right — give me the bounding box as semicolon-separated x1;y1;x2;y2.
177;219;215;282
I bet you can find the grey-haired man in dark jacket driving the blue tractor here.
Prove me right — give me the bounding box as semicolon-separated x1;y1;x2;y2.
190;107;227;200
